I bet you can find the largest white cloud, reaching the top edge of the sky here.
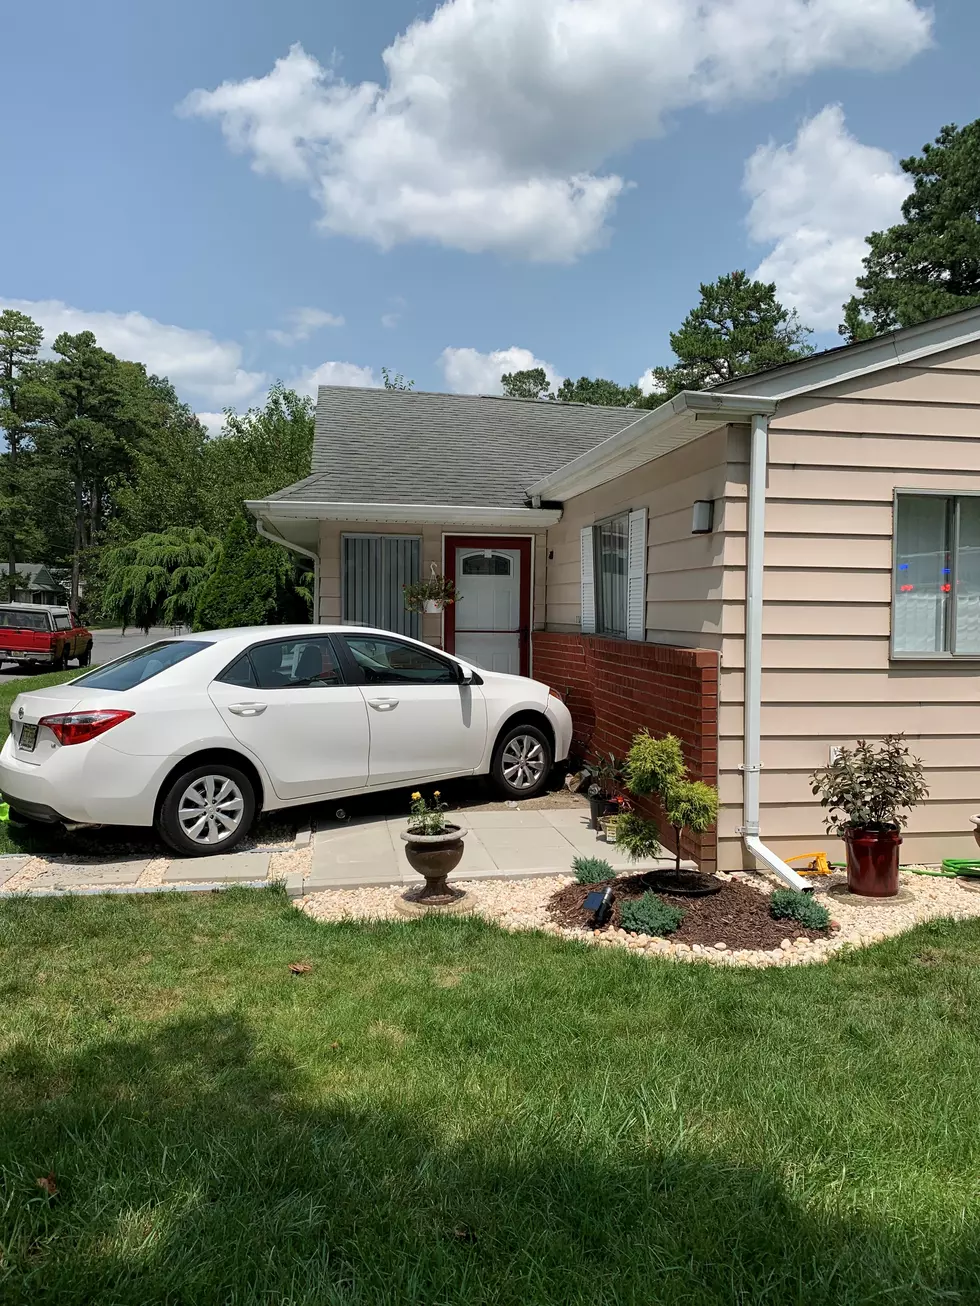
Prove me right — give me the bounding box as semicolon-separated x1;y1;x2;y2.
179;0;932;261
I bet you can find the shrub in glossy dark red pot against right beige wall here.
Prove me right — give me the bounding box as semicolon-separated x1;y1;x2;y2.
810;735;929;897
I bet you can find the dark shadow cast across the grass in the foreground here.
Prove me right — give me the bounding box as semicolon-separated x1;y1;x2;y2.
0;1008;980;1306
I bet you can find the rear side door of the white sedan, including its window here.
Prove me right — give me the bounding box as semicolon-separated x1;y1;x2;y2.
208;637;370;799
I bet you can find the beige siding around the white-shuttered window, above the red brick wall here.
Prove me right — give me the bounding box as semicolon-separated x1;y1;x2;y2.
546;430;727;648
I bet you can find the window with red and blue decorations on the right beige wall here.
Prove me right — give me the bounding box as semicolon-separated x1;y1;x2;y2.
891;494;980;657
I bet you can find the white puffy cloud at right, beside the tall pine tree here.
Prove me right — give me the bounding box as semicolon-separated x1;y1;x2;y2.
745;104;912;330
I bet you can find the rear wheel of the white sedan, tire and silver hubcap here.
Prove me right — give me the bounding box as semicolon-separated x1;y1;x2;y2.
154;761;255;857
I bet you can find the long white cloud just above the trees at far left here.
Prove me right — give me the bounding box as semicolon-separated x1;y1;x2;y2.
0;299;269;406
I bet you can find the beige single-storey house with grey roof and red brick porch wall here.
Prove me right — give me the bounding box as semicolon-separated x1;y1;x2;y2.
248;310;980;883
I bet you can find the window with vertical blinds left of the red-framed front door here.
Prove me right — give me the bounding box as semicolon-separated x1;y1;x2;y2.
341;535;422;639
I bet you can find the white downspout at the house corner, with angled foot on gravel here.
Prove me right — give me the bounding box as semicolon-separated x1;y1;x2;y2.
741;414;813;891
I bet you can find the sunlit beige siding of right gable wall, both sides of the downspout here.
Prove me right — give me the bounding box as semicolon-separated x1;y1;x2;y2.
719;346;980;870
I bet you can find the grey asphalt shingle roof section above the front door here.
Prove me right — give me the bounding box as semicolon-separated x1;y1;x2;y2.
270;385;645;508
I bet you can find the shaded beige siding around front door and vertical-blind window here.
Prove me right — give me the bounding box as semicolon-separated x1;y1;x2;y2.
319;521;547;648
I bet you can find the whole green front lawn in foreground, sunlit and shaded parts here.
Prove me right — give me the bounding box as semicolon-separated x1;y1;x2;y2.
0;889;980;1306
